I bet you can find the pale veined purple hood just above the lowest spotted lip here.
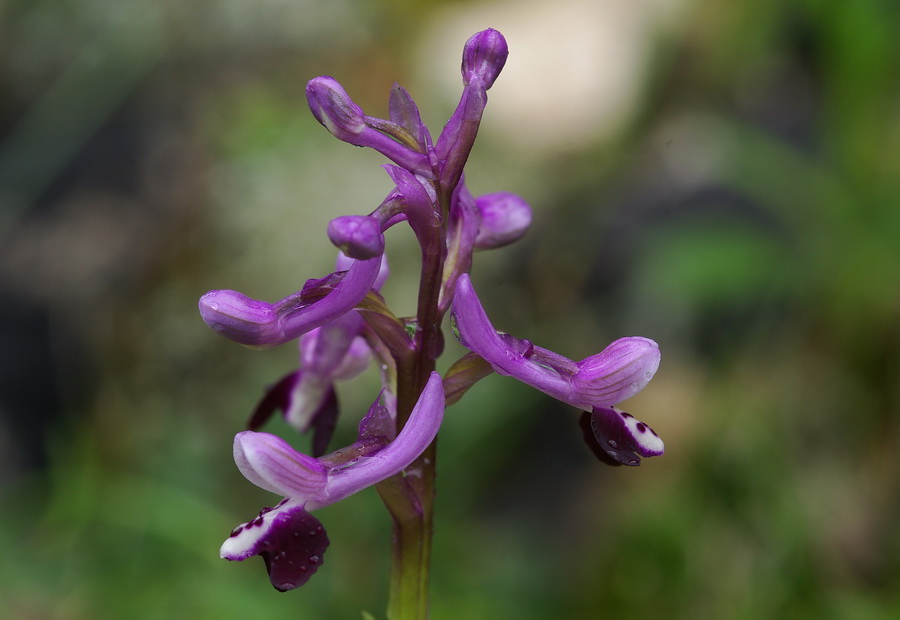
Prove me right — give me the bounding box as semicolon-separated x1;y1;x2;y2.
234;431;326;501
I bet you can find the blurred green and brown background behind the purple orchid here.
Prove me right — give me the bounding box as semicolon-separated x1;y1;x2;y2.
0;0;900;620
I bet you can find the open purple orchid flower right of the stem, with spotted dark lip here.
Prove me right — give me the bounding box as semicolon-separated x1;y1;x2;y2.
453;274;663;465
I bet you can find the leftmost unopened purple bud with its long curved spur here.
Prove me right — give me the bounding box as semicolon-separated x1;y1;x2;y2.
198;256;382;348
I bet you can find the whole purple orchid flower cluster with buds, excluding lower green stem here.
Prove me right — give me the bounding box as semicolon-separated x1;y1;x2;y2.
199;29;663;591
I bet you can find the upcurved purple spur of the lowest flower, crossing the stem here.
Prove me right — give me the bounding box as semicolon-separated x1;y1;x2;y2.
307;372;444;510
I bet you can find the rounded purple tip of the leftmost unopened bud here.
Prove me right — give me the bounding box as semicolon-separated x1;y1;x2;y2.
198;290;281;346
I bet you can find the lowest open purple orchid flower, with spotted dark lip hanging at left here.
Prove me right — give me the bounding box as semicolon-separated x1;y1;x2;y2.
220;372;444;592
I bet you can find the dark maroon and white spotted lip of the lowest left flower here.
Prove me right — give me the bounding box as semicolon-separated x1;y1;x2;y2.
219;500;329;592
